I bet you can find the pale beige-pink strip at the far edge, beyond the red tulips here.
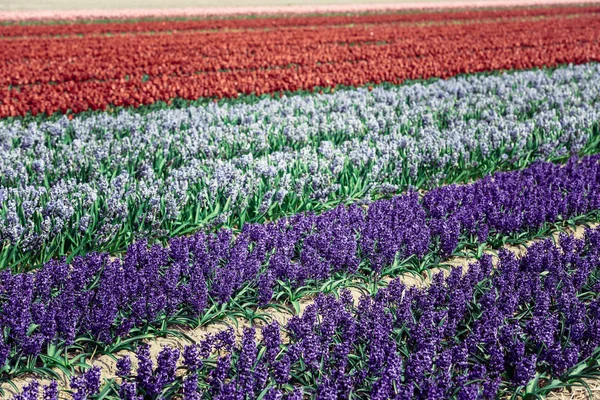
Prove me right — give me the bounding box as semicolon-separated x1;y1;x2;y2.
0;0;600;21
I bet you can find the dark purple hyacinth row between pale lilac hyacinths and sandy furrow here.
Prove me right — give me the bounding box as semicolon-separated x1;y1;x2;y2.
0;156;600;365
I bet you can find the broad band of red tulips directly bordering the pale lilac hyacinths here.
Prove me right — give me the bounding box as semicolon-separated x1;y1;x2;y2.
0;9;600;117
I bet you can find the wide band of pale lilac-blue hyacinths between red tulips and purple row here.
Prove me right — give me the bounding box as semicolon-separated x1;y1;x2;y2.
0;64;600;267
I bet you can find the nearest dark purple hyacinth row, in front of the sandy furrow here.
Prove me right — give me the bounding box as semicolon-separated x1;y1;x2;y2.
15;229;600;400
